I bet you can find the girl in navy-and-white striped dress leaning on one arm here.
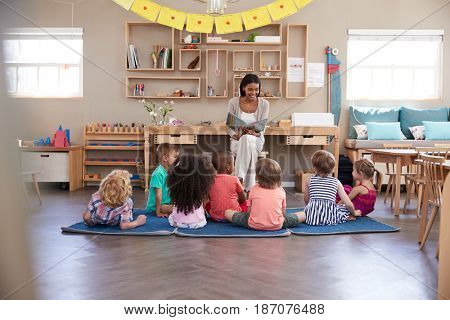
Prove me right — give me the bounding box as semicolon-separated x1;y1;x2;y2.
304;150;361;226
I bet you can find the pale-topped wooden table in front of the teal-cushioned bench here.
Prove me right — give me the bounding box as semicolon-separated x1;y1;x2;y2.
367;149;418;216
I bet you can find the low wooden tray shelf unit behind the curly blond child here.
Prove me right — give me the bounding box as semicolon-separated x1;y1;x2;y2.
83;126;144;186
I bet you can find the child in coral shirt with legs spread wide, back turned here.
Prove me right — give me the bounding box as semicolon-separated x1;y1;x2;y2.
225;159;305;230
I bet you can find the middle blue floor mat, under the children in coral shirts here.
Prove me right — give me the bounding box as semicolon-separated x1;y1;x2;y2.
175;221;291;238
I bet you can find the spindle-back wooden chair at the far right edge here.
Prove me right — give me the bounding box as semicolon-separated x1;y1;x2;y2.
420;154;445;256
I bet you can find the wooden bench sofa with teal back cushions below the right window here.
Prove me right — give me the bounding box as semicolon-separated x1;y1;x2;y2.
344;106;450;162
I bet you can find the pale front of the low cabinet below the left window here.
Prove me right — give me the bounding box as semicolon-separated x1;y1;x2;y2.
22;152;69;182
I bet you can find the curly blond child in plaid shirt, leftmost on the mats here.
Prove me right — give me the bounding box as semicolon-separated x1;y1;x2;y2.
83;170;147;229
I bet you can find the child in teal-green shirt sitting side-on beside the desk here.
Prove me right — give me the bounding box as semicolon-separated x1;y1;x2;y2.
145;143;180;218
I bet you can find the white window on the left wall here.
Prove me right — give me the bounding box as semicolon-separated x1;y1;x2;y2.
3;28;83;98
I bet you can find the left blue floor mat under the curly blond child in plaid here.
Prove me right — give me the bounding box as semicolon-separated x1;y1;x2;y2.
61;210;175;236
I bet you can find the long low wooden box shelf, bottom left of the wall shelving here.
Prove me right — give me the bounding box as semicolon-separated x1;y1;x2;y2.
126;77;201;99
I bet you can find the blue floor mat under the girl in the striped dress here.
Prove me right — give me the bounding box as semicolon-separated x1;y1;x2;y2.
289;217;400;236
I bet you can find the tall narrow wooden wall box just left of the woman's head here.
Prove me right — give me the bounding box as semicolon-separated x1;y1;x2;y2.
205;49;228;99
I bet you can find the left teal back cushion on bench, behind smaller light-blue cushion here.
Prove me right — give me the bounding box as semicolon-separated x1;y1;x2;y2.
348;106;400;139
